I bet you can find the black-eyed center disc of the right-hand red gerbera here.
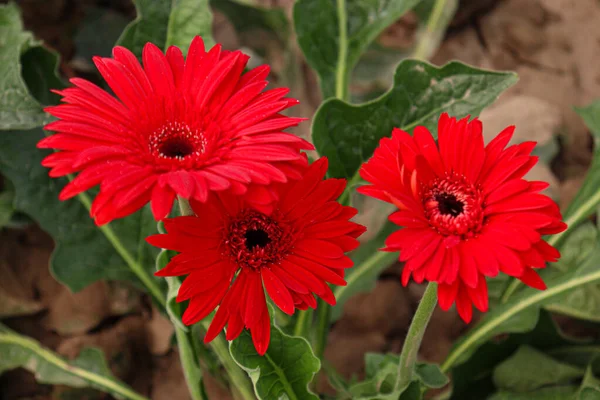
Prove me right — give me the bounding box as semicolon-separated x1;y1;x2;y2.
421;173;483;239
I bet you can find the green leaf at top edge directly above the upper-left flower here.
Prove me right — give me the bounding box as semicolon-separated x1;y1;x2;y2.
117;0;213;58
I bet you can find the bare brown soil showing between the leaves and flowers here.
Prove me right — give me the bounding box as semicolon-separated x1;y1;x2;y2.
0;0;600;400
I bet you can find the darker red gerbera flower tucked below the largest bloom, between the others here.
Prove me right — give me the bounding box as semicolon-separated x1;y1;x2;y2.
148;158;364;355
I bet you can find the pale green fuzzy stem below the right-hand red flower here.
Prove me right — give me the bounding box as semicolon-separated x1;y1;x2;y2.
394;282;437;390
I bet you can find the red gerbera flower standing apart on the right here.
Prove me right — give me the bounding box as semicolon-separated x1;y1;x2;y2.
359;113;566;322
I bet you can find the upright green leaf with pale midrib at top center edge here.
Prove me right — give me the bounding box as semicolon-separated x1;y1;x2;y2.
294;0;419;99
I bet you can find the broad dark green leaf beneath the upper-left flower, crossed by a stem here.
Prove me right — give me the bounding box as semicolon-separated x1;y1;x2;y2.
0;128;160;291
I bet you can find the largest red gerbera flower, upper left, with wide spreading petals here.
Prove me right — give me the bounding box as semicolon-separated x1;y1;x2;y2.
38;37;312;225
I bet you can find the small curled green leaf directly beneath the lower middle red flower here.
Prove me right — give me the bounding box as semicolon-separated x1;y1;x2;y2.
229;326;321;400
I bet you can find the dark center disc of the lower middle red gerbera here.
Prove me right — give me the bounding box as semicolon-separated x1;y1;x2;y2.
223;209;293;269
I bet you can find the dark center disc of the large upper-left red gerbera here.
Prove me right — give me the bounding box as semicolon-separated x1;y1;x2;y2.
148;122;206;160
